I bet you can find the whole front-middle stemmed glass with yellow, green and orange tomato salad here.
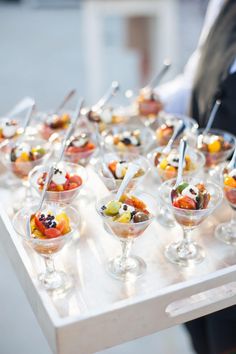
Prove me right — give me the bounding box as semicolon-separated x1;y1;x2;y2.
96;192;156;280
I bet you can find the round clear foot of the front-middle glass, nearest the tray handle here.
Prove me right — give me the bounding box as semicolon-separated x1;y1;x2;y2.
107;256;146;281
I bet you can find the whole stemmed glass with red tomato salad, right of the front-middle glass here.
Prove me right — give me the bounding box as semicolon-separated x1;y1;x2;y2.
160;177;222;267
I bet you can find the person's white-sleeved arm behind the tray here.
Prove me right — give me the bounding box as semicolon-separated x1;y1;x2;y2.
156;0;224;114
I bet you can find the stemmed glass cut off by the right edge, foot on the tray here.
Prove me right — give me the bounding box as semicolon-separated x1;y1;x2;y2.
215;173;236;246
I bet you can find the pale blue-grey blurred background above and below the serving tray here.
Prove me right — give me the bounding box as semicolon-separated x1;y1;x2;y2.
0;0;207;354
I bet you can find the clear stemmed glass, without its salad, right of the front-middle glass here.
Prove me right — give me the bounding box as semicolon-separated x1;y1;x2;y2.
160;177;223;267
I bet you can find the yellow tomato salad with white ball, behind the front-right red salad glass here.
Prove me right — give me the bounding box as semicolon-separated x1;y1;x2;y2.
154;149;197;180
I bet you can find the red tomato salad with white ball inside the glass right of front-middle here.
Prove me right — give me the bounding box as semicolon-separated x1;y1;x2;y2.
171;182;210;210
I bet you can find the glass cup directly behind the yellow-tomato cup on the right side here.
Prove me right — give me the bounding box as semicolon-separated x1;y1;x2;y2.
150;111;198;146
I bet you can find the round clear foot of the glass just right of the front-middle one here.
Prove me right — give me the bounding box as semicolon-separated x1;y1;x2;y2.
165;241;205;267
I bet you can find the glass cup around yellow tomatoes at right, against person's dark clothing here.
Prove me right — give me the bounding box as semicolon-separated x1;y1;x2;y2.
197;129;236;176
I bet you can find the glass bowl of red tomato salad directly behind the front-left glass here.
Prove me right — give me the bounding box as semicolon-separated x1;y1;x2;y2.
29;161;87;203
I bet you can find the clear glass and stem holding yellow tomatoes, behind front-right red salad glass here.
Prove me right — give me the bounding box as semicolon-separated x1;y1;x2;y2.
148;147;205;228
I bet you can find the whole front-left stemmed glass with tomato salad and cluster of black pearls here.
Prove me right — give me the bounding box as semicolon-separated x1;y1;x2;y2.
13;203;80;294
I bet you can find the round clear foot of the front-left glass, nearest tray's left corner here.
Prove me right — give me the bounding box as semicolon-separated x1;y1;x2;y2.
38;271;73;295
